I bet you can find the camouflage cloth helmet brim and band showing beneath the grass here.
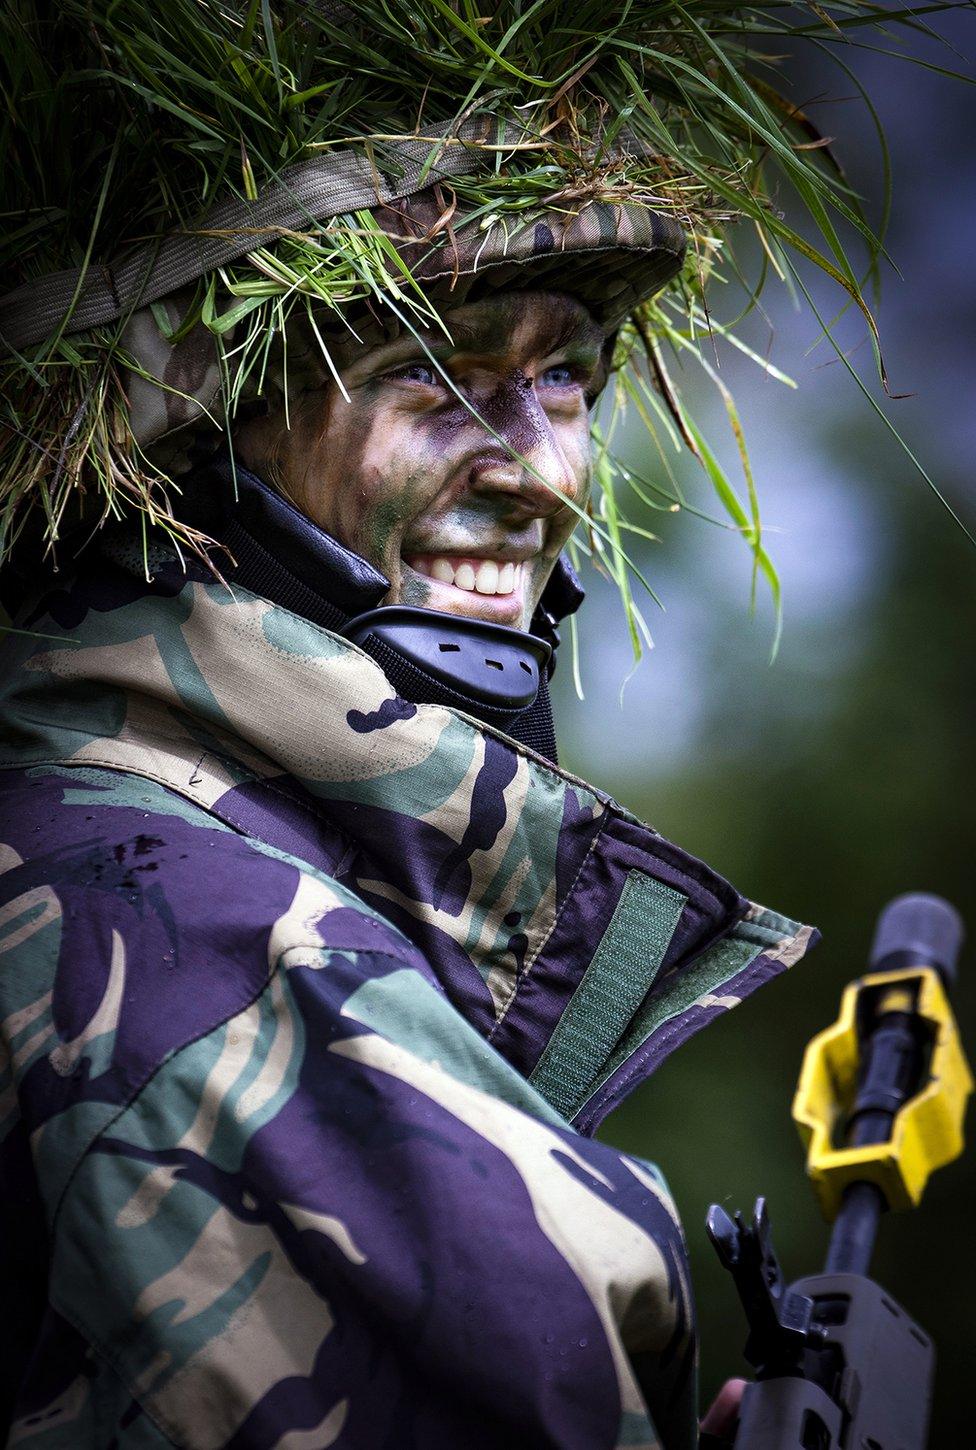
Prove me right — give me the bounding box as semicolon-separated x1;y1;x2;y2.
0;126;686;476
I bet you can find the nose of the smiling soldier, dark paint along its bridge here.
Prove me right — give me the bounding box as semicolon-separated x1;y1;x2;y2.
468;370;580;518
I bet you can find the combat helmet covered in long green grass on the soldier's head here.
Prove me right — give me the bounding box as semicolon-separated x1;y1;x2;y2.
0;0;922;635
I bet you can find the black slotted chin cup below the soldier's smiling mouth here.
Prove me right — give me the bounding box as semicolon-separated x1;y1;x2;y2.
342;605;553;725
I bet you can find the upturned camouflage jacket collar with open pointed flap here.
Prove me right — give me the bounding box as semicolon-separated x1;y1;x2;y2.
3;548;816;1132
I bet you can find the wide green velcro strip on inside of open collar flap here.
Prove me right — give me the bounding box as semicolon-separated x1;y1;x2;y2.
529;871;687;1118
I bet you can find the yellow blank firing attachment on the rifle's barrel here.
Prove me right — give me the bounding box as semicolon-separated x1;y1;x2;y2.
793;967;973;1222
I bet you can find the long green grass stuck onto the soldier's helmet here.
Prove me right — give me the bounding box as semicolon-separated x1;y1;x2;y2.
0;0;968;657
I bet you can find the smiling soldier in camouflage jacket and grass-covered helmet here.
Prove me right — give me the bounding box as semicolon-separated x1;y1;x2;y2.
0;0;922;1450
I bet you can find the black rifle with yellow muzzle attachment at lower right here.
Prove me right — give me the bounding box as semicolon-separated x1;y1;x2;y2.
699;893;973;1450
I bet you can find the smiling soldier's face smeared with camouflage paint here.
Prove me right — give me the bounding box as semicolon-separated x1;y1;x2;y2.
238;291;605;629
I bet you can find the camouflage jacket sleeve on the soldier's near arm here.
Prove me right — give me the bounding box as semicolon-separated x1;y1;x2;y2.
1;771;695;1450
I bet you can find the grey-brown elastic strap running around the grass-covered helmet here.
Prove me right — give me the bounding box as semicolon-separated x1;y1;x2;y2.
0;117;501;351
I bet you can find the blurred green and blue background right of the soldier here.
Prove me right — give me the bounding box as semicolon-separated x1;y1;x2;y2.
555;9;976;1447
